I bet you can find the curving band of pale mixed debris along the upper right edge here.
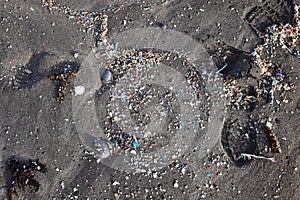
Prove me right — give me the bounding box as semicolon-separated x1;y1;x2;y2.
221;5;300;109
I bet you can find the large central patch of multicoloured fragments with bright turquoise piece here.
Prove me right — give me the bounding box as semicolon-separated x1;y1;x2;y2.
95;48;209;162
